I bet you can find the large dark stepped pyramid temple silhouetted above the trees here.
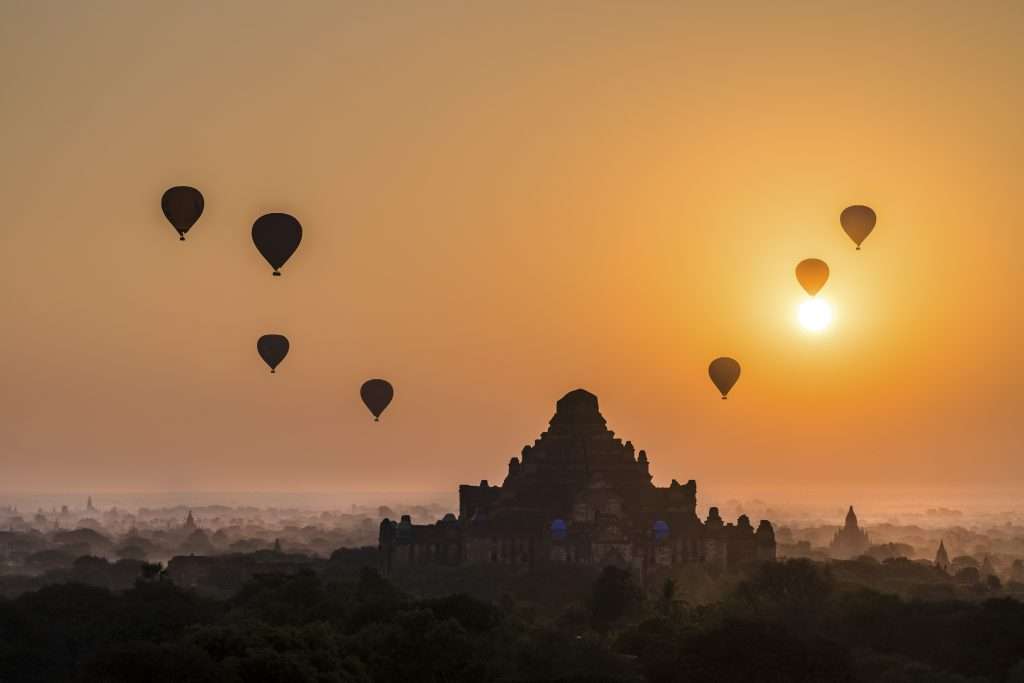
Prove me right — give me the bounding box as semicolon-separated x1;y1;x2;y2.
380;389;775;573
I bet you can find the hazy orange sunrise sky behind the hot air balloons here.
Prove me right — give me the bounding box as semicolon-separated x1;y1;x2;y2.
0;0;1024;500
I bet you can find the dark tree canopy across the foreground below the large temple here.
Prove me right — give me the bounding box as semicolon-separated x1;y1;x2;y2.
0;560;1024;683
